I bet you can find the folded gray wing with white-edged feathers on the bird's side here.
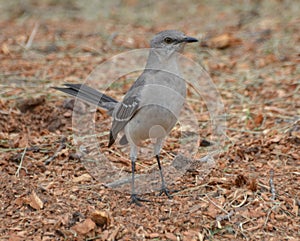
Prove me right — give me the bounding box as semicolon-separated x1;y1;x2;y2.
108;72;145;147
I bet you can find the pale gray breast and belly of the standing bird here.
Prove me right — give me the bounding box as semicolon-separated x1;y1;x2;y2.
125;75;186;145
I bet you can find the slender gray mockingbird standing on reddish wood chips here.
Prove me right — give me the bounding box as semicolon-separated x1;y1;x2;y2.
54;30;198;205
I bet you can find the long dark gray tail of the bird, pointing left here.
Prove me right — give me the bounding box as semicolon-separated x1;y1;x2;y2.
52;84;118;113
